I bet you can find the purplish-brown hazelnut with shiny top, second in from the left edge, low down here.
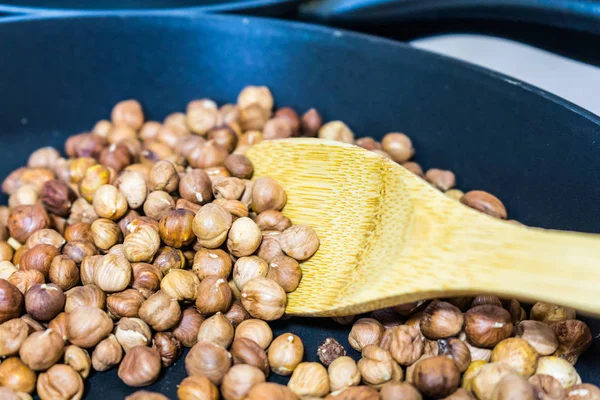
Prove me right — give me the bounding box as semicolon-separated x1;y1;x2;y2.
25;283;66;321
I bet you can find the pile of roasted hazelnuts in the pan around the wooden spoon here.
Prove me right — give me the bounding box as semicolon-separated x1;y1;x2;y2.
0;86;600;400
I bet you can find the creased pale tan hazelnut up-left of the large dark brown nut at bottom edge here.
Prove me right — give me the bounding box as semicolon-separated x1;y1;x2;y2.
357;344;403;389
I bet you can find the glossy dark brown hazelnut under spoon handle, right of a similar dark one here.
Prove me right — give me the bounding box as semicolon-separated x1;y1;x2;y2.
464;305;513;348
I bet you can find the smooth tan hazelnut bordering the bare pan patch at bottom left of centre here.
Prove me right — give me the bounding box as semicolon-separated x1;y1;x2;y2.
185;342;231;385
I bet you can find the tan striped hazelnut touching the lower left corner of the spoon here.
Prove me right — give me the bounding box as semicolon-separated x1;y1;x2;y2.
241;277;287;321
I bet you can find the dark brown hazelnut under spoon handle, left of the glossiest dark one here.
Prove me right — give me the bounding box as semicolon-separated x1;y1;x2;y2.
421;301;464;340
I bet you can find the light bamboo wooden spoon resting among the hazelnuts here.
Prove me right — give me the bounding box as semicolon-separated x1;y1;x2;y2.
246;138;600;316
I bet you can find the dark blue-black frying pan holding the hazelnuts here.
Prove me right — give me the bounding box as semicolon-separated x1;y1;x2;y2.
0;12;600;399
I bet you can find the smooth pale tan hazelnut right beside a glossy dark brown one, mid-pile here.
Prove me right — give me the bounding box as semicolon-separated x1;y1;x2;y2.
192;204;232;248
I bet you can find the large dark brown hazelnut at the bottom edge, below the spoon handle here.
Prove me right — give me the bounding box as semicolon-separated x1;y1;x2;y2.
413;356;460;399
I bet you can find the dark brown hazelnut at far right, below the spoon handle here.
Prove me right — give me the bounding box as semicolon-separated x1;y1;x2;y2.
550;319;592;364
